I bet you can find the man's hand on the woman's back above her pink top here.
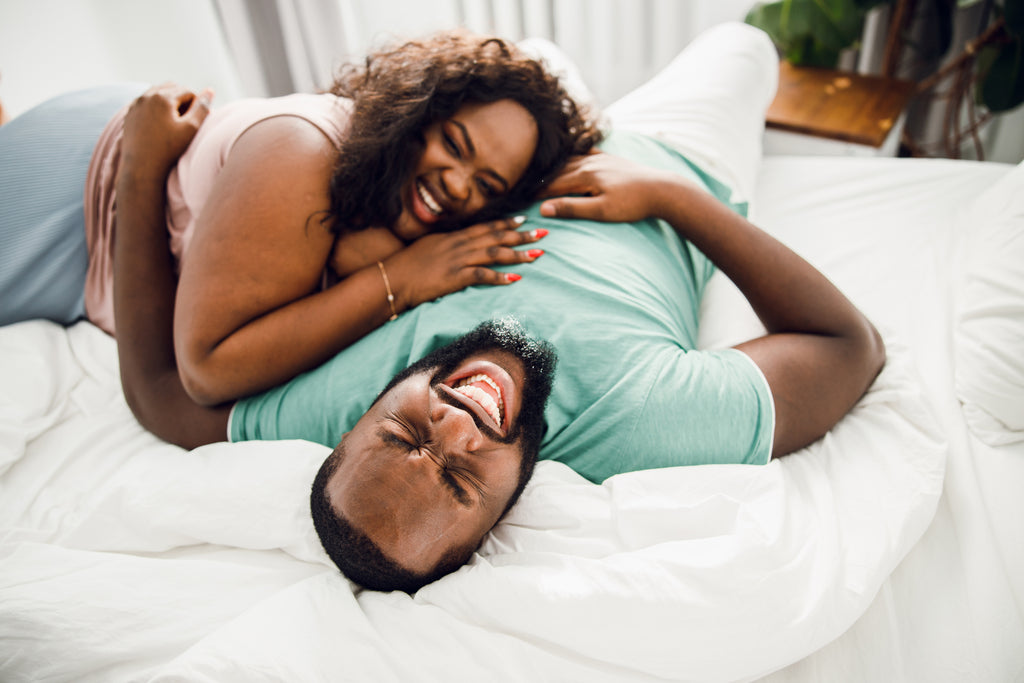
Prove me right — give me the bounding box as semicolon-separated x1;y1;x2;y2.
121;83;213;178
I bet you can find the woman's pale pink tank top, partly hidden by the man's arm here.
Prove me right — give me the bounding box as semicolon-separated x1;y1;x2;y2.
85;94;351;335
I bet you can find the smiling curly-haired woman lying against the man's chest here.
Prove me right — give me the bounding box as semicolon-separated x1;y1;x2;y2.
0;33;598;404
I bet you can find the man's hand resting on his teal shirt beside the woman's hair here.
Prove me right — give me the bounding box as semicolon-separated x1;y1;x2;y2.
541;153;681;223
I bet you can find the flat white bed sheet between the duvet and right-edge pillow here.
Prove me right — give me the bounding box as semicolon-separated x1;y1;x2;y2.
755;158;1024;681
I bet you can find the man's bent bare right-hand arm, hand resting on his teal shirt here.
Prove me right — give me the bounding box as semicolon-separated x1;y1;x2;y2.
541;155;885;456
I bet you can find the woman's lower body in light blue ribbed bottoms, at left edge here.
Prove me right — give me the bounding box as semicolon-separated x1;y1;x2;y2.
0;84;140;325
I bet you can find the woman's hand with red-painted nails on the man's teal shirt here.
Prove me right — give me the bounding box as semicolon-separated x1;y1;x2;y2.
384;218;548;310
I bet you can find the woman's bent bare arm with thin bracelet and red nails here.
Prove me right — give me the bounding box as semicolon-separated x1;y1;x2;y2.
174;117;537;404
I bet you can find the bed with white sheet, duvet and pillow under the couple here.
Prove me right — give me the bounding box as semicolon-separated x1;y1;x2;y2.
0;33;1024;683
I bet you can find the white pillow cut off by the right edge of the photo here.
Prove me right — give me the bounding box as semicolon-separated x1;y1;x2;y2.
953;163;1024;445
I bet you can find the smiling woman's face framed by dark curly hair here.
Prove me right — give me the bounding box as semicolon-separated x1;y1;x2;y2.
391;99;537;242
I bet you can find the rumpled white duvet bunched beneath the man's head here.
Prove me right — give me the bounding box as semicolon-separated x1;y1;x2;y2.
0;301;946;681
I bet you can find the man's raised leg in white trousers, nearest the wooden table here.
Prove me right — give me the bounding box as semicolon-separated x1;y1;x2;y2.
605;23;778;201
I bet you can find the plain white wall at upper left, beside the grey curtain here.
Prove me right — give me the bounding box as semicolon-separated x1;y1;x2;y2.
0;0;241;117
